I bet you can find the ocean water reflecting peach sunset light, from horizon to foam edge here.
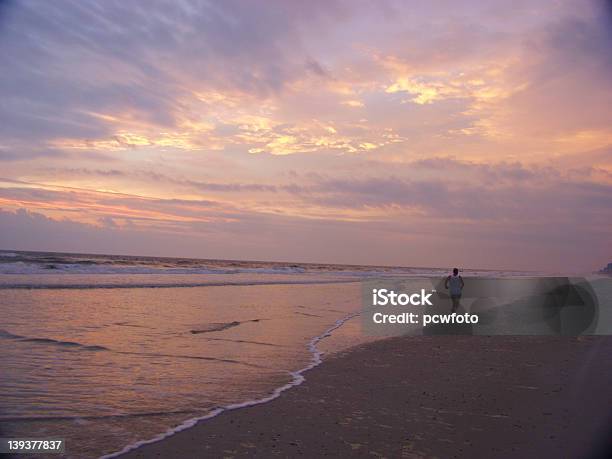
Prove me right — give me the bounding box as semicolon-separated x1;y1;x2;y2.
0;251;524;458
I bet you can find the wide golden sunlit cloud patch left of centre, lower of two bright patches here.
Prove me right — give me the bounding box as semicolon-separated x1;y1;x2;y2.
55;93;403;155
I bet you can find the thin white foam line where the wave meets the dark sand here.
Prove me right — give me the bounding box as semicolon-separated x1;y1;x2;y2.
100;311;360;459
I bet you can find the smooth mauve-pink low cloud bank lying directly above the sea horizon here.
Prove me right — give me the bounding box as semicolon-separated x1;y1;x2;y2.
0;199;607;271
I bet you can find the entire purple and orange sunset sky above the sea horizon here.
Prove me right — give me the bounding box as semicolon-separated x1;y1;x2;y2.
0;0;612;271
